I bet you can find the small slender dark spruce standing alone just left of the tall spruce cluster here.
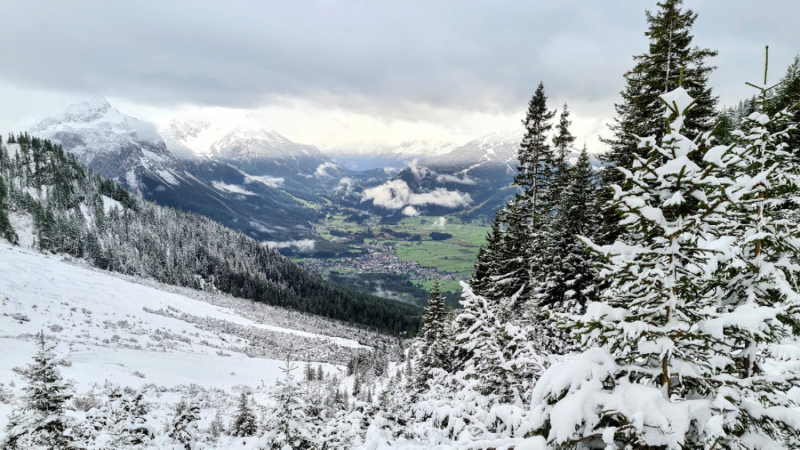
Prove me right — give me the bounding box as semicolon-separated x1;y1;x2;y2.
412;280;451;393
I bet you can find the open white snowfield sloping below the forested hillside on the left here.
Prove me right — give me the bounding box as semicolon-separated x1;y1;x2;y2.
0;243;378;430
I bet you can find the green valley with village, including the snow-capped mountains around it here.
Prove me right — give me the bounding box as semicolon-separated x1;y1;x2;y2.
23;97;568;303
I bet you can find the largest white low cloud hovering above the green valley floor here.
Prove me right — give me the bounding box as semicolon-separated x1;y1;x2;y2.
361;180;472;210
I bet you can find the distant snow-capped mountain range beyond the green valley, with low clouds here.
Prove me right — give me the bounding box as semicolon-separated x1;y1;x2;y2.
23;98;600;251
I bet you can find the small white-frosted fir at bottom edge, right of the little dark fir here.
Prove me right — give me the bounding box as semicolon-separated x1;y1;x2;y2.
257;357;318;450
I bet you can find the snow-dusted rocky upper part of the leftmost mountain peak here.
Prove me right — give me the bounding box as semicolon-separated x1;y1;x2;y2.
28;97;176;190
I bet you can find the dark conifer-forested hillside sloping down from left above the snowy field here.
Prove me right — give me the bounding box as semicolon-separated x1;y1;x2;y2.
0;134;418;333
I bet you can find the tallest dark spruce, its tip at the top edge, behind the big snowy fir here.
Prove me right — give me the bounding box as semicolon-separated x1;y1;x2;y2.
601;0;717;243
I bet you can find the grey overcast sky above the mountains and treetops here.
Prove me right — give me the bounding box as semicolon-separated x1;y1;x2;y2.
0;0;800;151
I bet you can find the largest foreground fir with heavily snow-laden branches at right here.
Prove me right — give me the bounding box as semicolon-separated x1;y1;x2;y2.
531;71;800;449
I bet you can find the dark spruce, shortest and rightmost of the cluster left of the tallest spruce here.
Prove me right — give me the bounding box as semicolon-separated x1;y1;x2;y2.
531;146;599;354
